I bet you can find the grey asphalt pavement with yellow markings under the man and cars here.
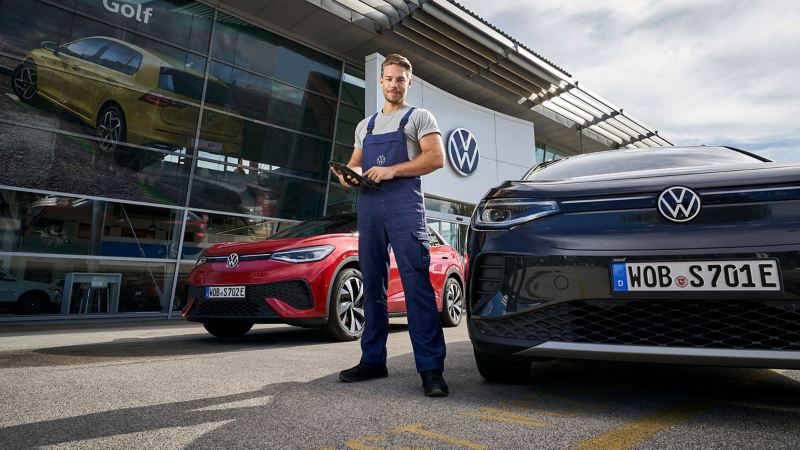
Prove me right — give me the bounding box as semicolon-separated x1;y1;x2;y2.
0;319;800;449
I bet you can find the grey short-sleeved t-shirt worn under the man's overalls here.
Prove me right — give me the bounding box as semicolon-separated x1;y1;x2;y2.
355;105;441;159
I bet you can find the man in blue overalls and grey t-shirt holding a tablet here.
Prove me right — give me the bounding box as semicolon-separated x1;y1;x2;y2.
334;54;448;397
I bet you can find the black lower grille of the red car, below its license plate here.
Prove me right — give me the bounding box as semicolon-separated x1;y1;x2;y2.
186;281;314;318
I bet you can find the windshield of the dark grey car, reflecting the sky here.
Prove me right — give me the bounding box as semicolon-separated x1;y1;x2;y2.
525;147;763;181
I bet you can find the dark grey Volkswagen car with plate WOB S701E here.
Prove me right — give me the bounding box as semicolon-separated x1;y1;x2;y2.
467;147;800;381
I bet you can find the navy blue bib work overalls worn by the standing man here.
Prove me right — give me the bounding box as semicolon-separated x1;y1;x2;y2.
358;108;445;372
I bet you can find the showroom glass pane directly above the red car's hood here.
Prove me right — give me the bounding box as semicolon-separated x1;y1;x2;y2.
182;210;293;261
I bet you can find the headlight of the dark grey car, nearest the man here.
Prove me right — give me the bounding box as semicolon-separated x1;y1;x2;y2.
473;198;561;229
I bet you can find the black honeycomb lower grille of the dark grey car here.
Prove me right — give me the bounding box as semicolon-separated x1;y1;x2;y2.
474;299;800;350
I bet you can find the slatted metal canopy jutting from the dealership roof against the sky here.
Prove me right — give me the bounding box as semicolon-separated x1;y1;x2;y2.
316;0;672;148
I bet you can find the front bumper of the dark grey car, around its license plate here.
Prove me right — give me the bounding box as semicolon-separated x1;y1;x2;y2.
468;245;800;368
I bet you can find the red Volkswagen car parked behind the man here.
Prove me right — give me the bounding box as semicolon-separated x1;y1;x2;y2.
183;214;464;341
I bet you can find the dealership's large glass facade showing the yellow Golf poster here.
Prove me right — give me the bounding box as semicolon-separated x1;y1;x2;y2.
0;0;364;320
